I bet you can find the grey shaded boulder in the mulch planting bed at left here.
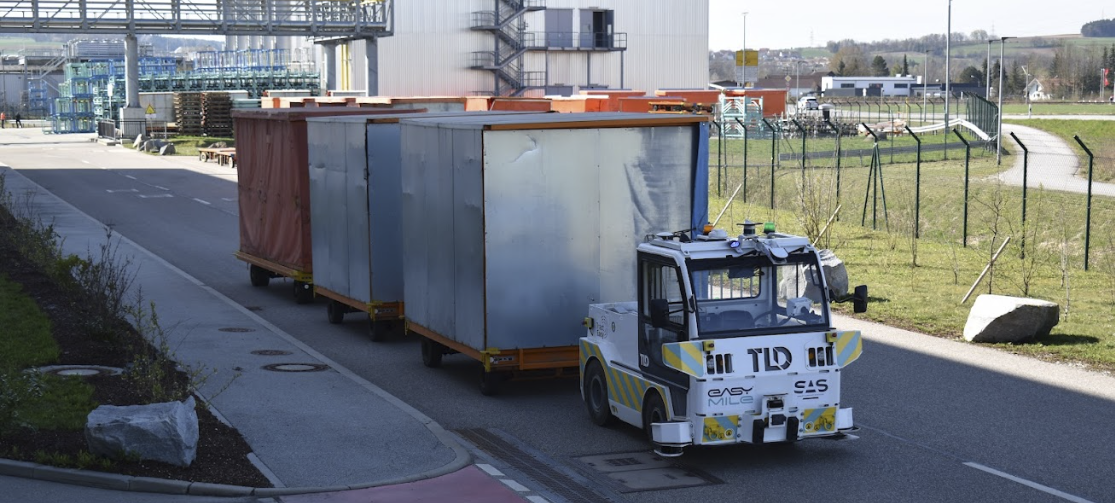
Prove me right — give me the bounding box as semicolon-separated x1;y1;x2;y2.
85;397;198;466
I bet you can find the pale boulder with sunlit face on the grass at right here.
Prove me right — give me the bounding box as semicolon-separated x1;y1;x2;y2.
964;294;1060;342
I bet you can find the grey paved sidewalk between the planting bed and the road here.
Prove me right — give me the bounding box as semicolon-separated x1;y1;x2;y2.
0;155;523;503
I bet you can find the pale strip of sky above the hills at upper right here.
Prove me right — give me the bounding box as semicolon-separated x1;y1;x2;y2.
708;0;1115;50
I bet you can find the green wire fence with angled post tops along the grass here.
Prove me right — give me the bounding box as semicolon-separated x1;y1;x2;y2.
709;115;1115;277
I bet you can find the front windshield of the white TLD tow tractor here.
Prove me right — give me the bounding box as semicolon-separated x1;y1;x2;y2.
688;254;830;338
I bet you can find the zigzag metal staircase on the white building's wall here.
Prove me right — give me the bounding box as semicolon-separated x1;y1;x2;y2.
469;0;546;96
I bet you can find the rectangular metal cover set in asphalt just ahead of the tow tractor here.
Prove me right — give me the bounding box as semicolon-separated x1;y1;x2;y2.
576;452;724;493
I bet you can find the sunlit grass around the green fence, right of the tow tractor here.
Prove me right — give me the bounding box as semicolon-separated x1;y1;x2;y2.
709;129;1115;370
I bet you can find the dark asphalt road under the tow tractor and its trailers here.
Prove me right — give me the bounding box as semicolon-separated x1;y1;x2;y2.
0;129;1115;503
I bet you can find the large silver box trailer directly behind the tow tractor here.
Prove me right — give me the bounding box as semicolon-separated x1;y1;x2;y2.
401;113;708;394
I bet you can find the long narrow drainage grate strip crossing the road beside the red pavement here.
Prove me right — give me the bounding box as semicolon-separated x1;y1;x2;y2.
454;428;618;503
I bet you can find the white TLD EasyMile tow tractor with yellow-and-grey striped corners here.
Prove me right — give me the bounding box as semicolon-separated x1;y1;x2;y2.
580;222;867;456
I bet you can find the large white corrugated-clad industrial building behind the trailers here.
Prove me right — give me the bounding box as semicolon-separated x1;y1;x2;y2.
225;0;708;96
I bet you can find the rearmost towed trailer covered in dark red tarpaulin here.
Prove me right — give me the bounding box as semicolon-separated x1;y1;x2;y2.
232;107;421;303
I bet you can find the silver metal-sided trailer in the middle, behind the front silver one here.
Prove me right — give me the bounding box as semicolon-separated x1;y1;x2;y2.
307;112;541;340
